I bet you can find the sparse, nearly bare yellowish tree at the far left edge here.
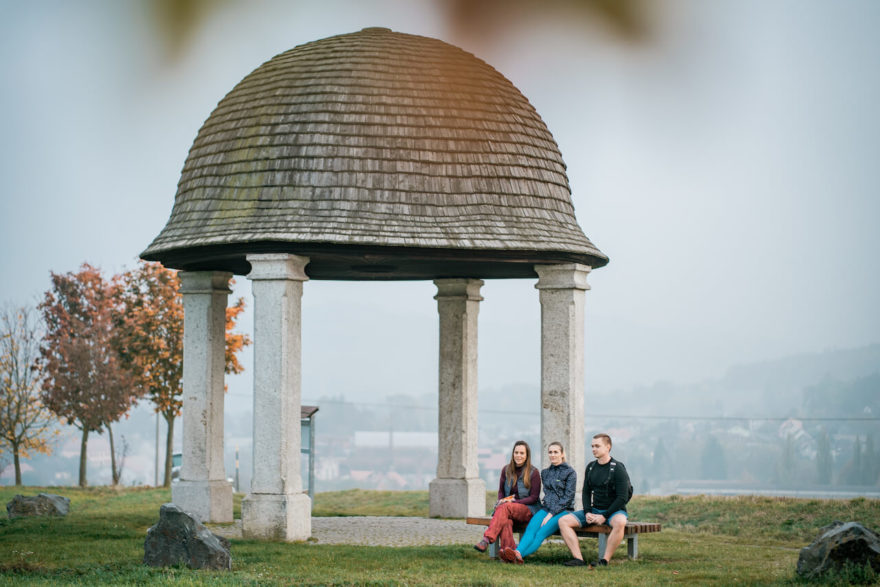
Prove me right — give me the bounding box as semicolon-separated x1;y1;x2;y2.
0;307;58;485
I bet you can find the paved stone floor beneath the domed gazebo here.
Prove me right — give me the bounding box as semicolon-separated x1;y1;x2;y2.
211;516;486;546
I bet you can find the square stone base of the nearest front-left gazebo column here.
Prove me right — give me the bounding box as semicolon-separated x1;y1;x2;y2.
241;493;312;542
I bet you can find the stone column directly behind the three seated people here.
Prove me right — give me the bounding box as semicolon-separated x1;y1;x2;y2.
535;263;592;504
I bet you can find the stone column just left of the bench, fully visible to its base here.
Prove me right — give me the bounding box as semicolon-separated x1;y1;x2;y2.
429;279;486;518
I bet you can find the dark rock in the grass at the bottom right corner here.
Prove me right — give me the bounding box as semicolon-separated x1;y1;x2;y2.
797;522;880;579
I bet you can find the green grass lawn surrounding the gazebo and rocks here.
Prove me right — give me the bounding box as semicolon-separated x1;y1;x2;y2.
0;487;880;585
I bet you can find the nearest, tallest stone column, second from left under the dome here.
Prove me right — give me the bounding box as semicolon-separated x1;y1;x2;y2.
241;254;312;540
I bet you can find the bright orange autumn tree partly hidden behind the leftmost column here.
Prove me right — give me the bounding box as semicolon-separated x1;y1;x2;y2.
117;262;251;487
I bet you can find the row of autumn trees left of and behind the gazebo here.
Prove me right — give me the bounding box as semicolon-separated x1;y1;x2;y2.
0;262;251;487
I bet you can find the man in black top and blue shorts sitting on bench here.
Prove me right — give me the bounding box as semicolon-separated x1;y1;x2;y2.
559;434;632;568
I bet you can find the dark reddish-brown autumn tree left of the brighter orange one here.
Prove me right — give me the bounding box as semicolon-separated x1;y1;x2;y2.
39;263;139;487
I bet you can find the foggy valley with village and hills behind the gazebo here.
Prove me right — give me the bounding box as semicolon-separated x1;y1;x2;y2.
8;344;880;498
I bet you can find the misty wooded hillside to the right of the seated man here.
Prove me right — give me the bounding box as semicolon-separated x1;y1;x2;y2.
617;372;880;491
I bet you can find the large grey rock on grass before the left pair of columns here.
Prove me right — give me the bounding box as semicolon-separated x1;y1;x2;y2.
144;503;232;570
